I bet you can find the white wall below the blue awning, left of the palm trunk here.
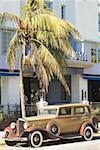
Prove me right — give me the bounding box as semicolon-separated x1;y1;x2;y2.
1;76;19;105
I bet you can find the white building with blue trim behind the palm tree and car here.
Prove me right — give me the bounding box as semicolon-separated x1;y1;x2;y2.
0;0;100;110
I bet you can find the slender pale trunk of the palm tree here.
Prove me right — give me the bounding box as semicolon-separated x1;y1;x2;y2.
20;45;26;118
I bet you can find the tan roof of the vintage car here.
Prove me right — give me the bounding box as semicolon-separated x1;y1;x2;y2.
44;103;90;109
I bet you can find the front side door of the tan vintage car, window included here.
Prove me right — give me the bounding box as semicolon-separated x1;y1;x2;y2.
57;107;72;133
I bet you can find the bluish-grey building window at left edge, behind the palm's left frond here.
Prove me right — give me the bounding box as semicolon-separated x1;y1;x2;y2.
1;31;14;54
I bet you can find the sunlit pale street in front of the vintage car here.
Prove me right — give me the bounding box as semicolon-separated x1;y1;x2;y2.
0;136;100;150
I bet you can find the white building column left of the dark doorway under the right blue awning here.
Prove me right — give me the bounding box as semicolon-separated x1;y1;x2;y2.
71;74;88;103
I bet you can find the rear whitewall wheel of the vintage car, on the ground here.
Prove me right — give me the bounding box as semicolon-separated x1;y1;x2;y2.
83;126;93;141
